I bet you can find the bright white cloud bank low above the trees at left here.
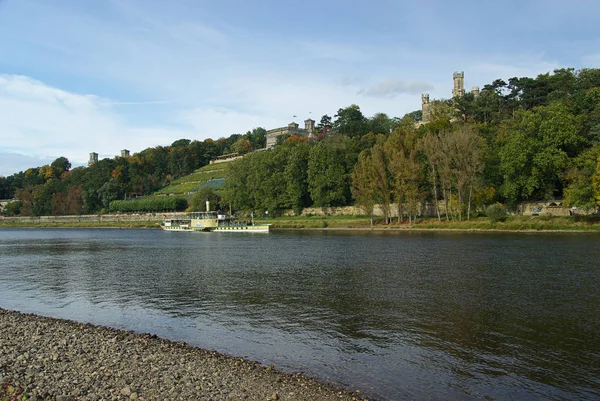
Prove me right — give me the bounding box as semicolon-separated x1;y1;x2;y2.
0;75;193;175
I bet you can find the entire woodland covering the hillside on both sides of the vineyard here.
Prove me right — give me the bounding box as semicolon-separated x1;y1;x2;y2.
0;68;600;219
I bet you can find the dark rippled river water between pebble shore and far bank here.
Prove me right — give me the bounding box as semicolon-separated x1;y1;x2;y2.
0;229;600;400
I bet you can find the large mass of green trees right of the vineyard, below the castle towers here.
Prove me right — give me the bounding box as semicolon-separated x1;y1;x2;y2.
223;69;600;221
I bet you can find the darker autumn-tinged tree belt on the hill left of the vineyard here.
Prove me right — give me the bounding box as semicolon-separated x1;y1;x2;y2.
0;128;266;216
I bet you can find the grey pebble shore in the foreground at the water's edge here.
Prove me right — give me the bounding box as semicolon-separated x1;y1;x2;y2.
0;309;364;401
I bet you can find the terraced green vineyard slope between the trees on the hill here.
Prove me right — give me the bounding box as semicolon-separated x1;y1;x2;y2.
152;162;230;196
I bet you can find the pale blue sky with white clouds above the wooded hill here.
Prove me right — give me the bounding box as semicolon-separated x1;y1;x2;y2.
0;0;600;176
